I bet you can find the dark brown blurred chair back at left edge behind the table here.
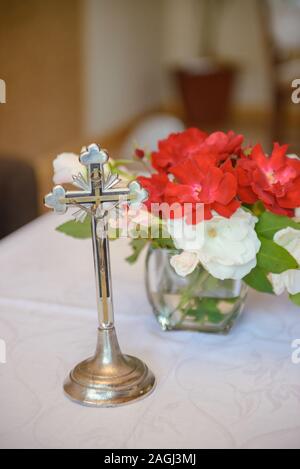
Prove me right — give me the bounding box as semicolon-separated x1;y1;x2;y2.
0;157;38;239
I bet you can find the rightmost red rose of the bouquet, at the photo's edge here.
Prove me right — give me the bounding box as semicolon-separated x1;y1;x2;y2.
237;143;300;217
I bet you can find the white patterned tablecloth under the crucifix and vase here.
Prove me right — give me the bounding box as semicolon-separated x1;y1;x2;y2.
0;215;300;449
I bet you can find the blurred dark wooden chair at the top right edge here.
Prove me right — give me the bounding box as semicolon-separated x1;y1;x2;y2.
257;0;300;142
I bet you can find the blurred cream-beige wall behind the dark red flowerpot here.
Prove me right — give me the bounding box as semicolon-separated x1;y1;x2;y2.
83;0;276;134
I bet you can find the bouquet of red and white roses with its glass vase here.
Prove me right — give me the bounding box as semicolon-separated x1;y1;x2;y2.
54;128;300;332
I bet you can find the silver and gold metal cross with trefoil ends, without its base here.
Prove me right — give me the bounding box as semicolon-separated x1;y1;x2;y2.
45;144;148;329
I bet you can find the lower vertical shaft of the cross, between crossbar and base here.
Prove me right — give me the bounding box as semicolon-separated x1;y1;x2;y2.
92;215;114;329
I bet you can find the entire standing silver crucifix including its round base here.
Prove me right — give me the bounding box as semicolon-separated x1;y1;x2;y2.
45;144;155;406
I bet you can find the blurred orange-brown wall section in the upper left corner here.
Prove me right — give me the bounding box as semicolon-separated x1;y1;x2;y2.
0;0;83;158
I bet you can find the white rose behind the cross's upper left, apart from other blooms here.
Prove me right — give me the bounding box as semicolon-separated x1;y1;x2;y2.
53;153;87;184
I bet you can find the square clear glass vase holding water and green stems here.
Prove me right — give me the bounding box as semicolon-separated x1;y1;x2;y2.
146;248;248;334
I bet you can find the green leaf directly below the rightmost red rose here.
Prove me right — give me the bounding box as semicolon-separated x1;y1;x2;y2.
256;212;300;240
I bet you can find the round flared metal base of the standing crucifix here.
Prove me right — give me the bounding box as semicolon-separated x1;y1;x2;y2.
64;327;155;407
